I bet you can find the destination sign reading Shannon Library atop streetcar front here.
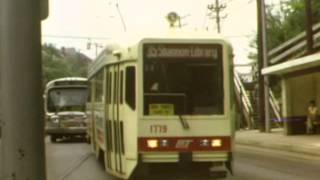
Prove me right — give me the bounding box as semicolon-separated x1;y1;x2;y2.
144;44;221;59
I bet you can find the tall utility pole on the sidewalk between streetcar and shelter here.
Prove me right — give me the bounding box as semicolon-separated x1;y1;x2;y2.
257;0;270;132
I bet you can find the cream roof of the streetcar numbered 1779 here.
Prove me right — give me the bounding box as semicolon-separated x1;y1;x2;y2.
88;30;231;78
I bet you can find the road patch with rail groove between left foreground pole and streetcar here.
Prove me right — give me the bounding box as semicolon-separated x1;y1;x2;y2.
46;138;112;180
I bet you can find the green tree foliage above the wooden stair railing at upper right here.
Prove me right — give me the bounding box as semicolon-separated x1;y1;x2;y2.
249;0;320;60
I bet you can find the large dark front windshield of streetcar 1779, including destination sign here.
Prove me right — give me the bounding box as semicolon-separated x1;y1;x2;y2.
144;45;224;115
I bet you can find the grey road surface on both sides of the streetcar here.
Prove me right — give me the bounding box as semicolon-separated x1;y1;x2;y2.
46;141;320;180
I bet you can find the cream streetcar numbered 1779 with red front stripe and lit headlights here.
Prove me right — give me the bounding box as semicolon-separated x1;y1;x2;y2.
88;32;234;179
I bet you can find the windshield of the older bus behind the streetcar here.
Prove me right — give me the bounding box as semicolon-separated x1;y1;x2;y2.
48;88;88;112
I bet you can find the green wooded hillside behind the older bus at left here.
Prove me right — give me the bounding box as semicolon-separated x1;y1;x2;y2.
42;44;91;85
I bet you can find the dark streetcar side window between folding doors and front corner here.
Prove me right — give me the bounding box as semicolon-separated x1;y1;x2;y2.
125;66;136;110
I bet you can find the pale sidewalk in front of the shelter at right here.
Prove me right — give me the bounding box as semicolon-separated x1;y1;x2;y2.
235;129;320;156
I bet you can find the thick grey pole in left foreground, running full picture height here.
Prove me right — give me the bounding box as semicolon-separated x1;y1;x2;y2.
0;0;46;180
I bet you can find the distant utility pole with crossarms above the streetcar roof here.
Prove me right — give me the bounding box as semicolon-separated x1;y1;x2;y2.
207;0;227;34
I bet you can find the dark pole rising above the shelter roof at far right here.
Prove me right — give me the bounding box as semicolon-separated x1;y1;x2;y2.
305;0;314;54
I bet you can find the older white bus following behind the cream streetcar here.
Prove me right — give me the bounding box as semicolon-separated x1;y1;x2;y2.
44;77;89;142
